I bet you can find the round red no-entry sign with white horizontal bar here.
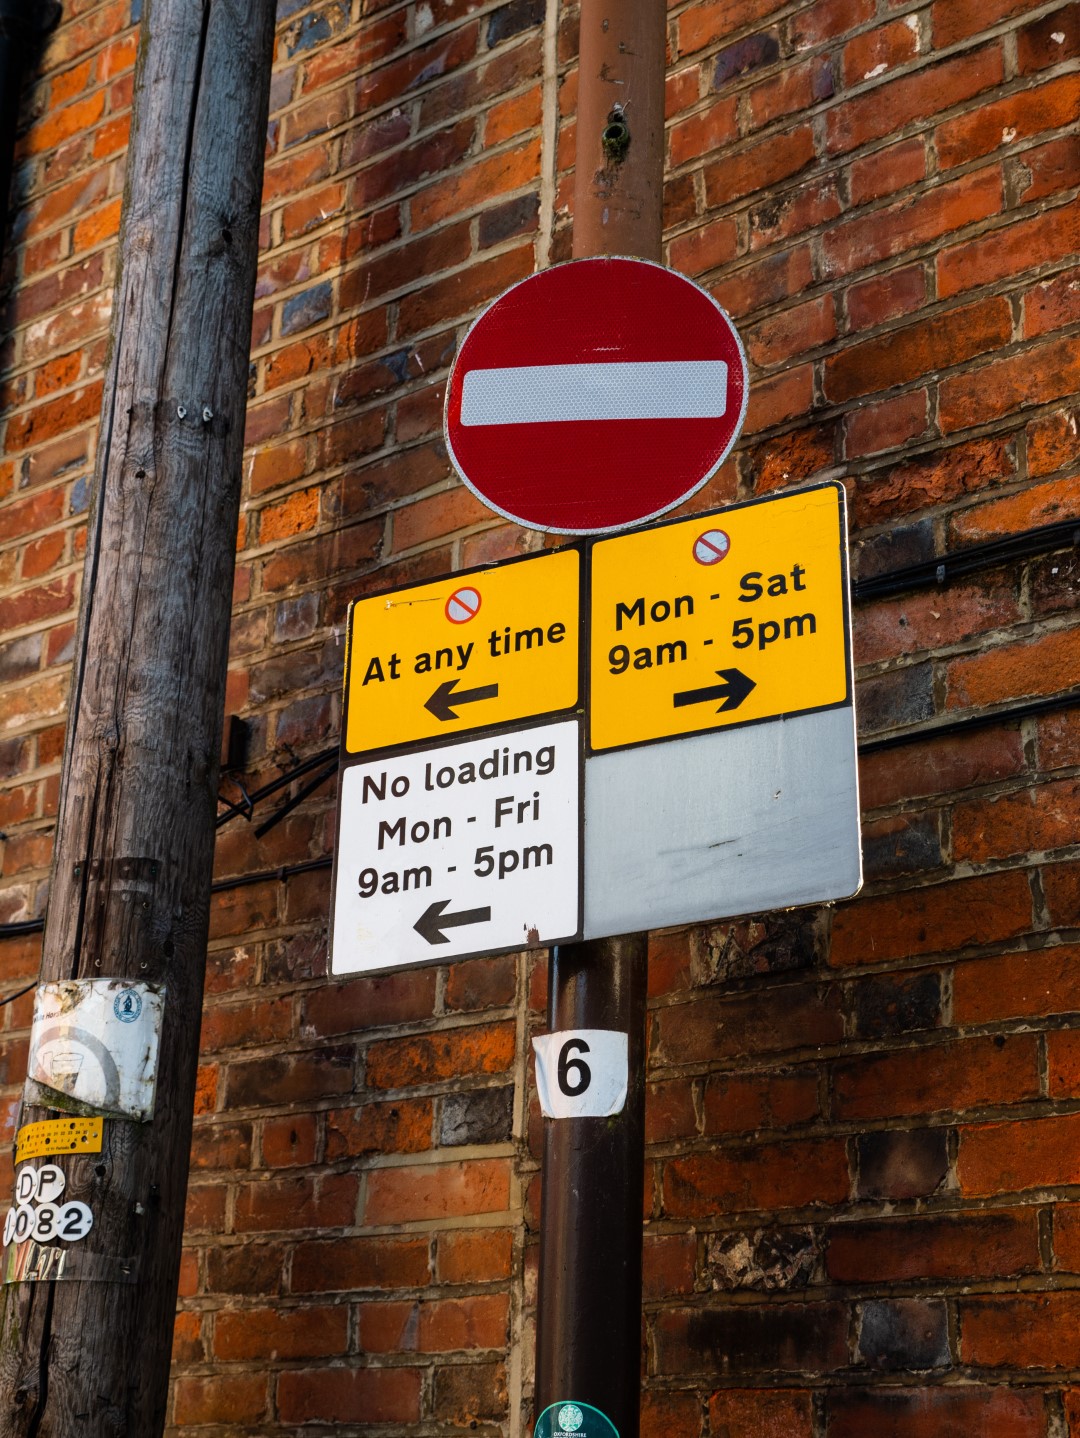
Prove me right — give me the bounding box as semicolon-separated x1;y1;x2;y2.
446;257;749;533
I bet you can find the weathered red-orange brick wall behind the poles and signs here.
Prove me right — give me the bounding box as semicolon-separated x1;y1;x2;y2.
0;0;1080;1438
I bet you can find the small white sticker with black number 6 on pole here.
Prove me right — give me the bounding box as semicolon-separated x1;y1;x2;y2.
532;1028;628;1119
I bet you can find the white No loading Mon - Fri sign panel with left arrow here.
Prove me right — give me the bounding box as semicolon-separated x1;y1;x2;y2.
332;719;581;974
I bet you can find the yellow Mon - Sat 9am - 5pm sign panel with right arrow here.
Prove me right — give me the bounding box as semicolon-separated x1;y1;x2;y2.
588;483;851;752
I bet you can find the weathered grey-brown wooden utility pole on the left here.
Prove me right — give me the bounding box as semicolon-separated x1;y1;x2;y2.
0;0;275;1438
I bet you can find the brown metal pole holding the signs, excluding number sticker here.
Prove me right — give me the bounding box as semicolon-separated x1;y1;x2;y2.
535;0;666;1438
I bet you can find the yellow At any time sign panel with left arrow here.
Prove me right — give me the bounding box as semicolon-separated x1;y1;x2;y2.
345;546;582;755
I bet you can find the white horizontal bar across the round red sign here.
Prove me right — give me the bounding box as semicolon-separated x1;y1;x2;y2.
462;360;728;426
